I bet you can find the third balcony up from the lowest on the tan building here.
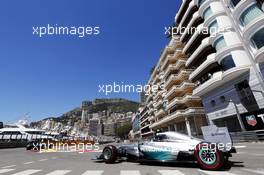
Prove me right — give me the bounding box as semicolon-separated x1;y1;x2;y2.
165;81;195;100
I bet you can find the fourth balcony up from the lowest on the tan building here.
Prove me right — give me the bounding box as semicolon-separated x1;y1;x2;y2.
164;69;192;89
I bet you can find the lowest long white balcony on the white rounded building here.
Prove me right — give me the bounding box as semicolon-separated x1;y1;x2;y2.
193;66;250;96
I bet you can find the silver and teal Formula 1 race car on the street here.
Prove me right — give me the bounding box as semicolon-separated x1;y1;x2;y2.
95;132;236;170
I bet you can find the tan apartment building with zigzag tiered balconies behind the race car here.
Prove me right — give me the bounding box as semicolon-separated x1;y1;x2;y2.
140;37;207;138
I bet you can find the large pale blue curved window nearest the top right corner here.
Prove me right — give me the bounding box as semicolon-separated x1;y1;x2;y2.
240;4;263;26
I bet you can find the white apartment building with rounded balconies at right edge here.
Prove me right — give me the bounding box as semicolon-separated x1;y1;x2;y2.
174;0;264;131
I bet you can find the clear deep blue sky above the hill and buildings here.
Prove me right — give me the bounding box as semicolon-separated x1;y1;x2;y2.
0;0;179;122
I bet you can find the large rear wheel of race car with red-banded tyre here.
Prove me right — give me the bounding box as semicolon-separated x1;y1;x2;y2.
194;143;225;170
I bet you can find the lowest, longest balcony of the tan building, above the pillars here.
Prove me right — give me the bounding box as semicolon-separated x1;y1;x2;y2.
149;107;205;129
